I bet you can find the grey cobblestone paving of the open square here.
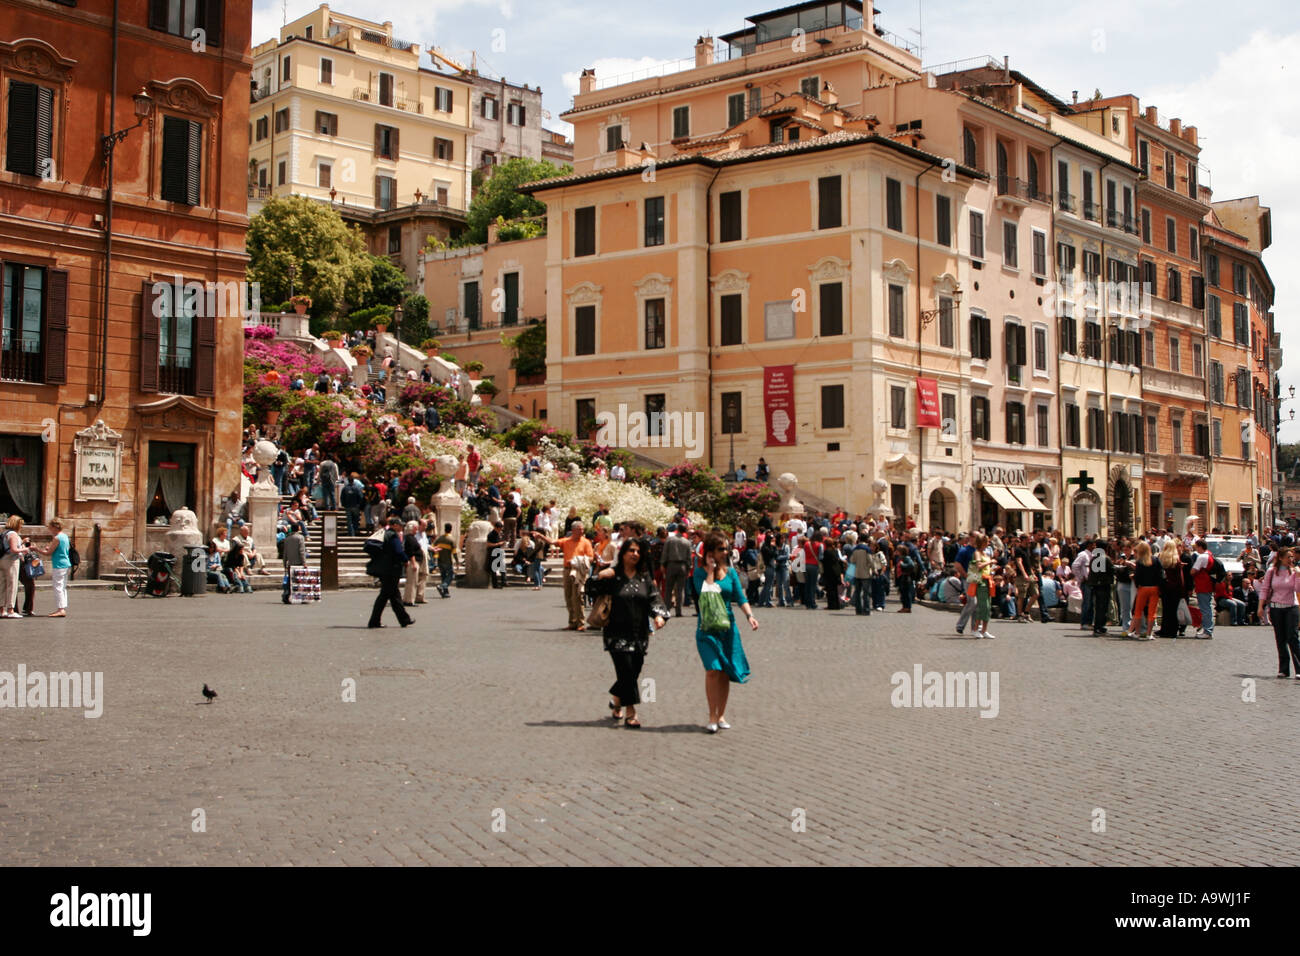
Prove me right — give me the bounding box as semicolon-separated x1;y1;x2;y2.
0;591;1300;865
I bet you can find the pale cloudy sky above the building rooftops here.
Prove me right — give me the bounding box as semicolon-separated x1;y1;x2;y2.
252;0;1300;442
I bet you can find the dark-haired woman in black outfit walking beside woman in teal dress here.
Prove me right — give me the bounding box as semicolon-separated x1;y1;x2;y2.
592;537;668;727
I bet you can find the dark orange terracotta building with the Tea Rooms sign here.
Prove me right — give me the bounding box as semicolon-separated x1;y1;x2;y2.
0;0;251;572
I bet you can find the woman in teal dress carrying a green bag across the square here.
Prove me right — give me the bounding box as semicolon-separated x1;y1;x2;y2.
696;532;758;734
